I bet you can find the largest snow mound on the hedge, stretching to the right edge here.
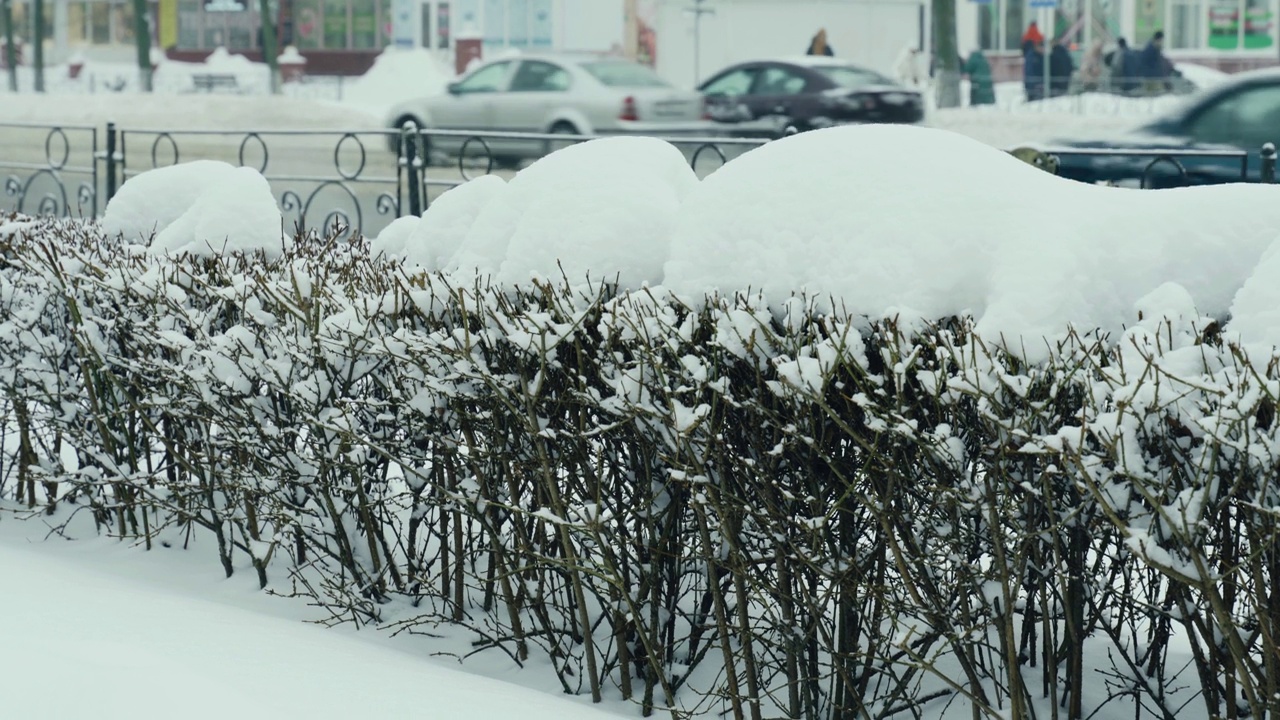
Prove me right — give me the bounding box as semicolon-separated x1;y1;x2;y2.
664;126;1280;352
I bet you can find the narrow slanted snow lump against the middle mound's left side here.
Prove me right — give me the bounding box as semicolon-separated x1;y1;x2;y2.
401;176;507;272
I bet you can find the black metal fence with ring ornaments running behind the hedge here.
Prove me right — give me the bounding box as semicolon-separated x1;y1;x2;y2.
0;123;1276;237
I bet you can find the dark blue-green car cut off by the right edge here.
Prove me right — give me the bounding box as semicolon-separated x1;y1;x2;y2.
1044;68;1280;187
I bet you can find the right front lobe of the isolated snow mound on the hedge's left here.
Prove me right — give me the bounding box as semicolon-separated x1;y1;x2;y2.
148;168;289;258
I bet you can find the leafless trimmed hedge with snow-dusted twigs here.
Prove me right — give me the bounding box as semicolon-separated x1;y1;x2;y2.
0;212;1280;717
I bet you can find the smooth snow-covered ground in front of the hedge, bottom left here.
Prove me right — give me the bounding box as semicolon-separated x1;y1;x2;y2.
0;521;635;720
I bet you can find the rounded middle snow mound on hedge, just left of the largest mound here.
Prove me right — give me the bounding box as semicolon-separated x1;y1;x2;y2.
448;137;699;288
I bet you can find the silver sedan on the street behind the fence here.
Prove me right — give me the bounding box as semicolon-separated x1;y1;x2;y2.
387;55;717;167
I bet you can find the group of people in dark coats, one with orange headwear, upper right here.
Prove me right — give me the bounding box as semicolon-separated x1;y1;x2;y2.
1023;22;1178;100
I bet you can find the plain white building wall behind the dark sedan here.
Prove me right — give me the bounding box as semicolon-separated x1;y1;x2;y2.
655;0;928;87
